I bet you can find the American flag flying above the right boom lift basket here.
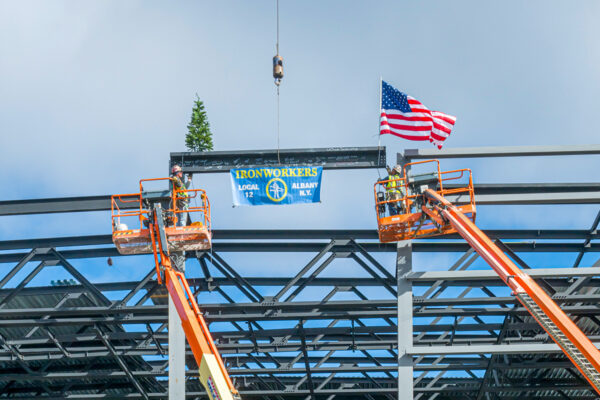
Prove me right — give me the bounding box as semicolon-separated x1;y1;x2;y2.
379;81;456;149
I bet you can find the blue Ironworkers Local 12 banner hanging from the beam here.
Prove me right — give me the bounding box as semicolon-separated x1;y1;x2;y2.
231;167;323;207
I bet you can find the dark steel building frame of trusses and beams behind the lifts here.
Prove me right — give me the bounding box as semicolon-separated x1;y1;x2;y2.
0;145;600;400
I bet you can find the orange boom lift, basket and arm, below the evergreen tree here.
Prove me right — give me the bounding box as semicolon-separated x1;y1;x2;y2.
111;178;240;400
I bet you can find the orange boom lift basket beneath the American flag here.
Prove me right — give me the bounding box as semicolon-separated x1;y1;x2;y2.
374;160;476;243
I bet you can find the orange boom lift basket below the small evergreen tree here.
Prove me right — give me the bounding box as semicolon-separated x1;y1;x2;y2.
111;178;212;254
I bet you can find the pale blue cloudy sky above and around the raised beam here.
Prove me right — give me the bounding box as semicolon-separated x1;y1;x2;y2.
0;0;600;282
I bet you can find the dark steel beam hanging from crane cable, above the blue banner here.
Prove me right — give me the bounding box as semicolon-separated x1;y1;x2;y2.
169;147;386;173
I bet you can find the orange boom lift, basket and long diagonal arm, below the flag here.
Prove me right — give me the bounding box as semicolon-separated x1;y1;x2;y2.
375;160;600;394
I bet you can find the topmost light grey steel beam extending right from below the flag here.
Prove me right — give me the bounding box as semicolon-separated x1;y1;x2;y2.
398;144;600;160
